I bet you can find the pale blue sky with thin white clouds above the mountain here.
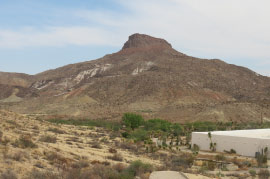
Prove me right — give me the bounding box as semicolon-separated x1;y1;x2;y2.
0;0;270;76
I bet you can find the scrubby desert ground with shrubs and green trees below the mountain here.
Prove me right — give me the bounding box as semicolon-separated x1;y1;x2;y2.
0;112;268;179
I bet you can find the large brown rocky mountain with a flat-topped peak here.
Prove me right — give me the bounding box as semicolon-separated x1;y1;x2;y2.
0;34;270;121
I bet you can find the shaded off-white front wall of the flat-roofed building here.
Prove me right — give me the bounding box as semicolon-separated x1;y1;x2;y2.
191;132;270;157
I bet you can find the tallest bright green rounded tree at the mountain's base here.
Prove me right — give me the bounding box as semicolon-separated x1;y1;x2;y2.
122;113;144;130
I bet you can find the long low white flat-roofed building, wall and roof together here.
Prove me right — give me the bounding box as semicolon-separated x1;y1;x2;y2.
191;129;270;157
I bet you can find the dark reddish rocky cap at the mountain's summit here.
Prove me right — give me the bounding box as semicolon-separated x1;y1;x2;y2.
122;33;172;49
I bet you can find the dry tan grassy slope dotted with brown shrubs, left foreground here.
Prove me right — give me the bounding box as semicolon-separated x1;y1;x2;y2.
0;110;185;179
